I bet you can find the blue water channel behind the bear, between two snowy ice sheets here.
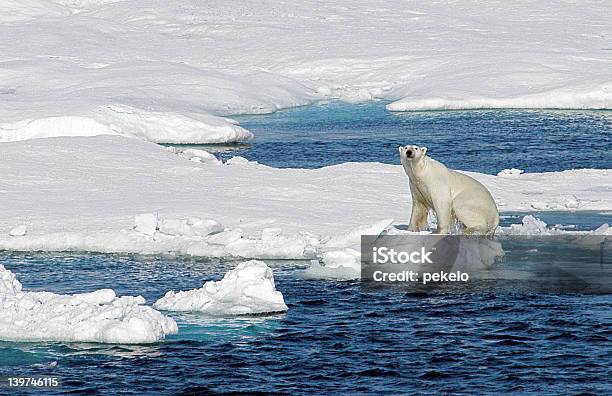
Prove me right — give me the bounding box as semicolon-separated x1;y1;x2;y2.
212;102;612;174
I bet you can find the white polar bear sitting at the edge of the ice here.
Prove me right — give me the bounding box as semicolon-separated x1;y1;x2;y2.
399;145;499;236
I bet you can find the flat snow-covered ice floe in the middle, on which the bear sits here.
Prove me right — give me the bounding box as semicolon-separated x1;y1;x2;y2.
0;136;612;260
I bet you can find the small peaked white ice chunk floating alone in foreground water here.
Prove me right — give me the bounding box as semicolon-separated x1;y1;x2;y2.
153;260;288;315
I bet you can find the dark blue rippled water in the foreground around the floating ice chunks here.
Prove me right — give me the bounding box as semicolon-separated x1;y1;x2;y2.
0;212;612;395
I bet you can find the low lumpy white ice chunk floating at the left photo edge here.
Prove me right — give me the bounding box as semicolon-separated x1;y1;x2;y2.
0;265;178;344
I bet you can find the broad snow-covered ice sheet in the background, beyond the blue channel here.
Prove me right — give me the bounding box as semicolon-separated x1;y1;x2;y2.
0;0;612;143
